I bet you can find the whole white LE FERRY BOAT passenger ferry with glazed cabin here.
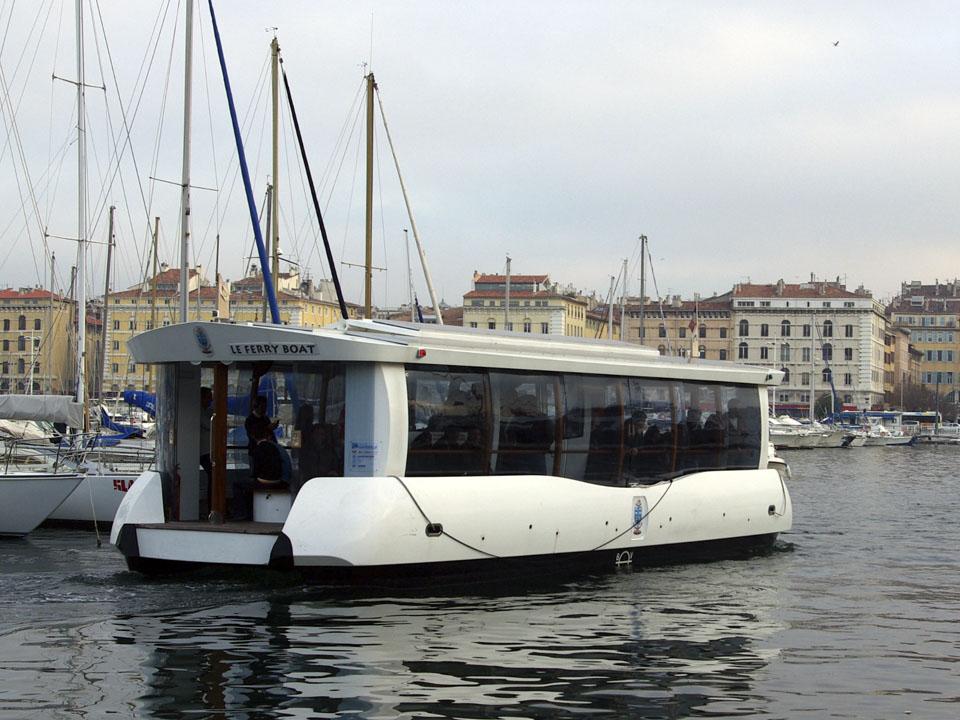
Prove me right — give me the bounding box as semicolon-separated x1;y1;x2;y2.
111;320;792;584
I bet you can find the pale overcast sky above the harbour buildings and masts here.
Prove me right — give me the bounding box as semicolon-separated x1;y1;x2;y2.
0;0;960;305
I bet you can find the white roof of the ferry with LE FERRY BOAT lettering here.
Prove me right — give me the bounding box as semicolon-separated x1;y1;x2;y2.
128;320;783;385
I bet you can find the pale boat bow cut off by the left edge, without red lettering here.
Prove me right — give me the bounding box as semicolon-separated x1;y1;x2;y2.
0;473;83;536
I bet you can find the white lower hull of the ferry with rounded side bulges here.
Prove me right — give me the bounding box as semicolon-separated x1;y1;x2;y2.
111;470;792;576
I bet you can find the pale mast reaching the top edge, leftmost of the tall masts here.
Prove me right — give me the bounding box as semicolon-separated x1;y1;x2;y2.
76;0;88;422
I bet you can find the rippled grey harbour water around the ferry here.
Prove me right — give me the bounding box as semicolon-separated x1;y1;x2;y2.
0;447;960;719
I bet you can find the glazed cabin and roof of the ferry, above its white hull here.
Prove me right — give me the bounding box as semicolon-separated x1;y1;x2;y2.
130;320;779;522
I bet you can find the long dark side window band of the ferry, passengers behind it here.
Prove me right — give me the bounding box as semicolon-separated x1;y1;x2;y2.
406;365;761;486
